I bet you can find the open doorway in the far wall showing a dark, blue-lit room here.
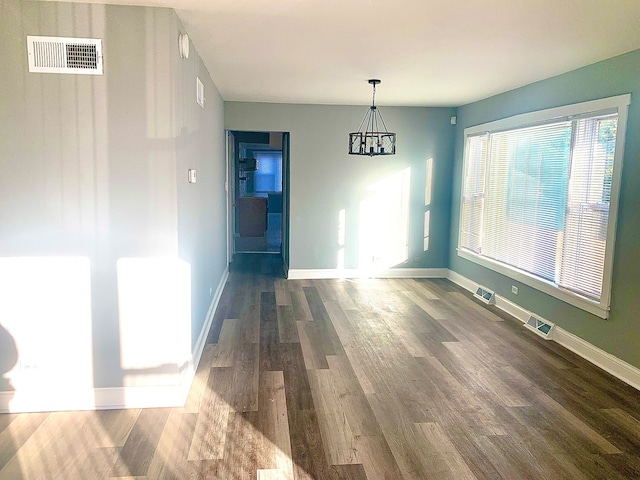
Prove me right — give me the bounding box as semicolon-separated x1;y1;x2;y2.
227;130;289;263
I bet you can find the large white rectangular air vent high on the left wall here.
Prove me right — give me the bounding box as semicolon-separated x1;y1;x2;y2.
27;36;102;75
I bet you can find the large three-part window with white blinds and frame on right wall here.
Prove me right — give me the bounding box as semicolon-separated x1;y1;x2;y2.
458;95;630;318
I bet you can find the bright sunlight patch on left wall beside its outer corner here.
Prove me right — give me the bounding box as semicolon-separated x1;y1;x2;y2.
117;258;191;386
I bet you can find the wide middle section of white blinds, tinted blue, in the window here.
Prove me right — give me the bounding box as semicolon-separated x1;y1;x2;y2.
482;122;571;281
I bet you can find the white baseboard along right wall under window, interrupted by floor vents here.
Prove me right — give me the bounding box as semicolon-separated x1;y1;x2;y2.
447;270;640;390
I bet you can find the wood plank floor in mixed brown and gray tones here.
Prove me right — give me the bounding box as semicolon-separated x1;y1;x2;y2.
0;255;640;480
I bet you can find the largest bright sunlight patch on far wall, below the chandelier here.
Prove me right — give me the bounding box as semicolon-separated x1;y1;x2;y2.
359;167;411;271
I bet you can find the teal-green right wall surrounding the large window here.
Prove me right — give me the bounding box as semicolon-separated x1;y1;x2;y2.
450;50;640;367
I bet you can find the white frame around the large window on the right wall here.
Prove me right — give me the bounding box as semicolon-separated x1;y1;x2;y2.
457;94;631;319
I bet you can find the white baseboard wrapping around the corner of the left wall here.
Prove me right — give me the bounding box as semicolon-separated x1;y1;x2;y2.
0;267;229;413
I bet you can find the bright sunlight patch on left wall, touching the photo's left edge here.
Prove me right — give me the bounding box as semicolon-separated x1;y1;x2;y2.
0;257;93;410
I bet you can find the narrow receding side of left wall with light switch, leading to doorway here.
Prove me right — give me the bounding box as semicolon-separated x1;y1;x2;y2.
169;14;227;348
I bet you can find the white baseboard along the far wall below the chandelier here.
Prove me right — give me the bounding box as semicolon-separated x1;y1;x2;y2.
287;268;449;280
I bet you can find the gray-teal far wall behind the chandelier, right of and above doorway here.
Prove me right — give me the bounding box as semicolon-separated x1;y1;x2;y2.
225;103;455;269
